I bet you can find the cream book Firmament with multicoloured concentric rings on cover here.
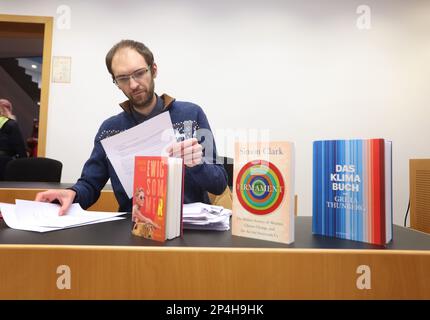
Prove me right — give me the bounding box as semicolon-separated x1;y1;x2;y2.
232;141;295;244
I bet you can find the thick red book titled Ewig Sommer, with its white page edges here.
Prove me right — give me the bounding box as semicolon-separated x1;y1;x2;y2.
132;156;184;242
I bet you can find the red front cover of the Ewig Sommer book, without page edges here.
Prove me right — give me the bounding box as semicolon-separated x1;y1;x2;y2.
132;156;168;241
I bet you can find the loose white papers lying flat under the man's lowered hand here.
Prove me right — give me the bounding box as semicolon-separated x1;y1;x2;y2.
0;200;125;232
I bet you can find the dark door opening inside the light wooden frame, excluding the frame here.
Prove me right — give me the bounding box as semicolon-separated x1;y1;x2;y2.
0;21;44;156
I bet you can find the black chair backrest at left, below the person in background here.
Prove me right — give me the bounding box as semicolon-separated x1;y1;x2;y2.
4;158;63;182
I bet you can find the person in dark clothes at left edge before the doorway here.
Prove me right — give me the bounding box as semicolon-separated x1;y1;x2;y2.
0;99;27;158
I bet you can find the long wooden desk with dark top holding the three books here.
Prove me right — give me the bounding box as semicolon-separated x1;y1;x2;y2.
0;215;430;300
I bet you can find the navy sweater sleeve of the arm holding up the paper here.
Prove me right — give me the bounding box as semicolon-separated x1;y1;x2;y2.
186;108;227;195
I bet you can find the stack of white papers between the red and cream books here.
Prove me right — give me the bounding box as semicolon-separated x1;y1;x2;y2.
183;202;231;231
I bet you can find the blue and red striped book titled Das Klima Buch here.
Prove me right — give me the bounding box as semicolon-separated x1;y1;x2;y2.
312;139;393;245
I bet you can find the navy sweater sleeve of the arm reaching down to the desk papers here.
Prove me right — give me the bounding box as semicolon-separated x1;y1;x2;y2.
70;125;109;209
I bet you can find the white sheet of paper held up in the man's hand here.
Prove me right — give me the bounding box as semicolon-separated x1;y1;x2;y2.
101;112;176;198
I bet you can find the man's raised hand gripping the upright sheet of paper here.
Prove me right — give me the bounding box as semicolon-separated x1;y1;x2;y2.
167;138;203;168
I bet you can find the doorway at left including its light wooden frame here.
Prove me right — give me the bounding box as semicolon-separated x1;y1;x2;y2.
0;15;53;157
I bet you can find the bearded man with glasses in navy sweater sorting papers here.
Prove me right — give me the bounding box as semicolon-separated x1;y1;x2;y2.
36;40;227;218
